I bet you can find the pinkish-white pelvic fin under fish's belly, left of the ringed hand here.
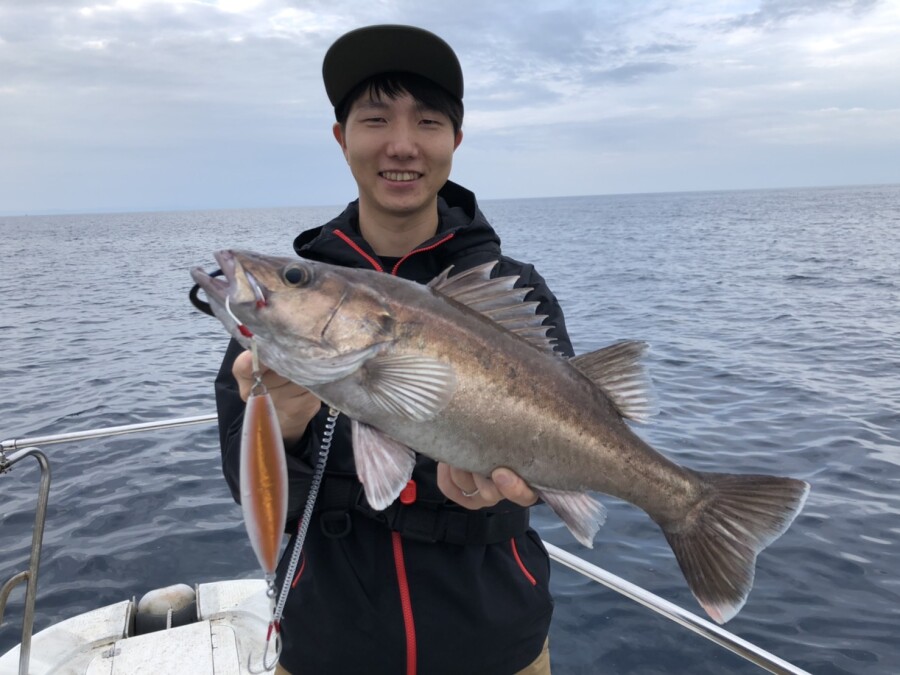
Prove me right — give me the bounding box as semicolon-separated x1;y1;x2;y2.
351;420;416;511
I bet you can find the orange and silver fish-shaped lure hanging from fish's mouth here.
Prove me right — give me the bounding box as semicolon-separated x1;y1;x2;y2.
240;384;288;584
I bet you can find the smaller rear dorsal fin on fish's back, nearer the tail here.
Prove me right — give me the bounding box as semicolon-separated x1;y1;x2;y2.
569;340;656;422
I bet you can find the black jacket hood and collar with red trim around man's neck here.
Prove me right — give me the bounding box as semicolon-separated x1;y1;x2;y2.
294;181;500;283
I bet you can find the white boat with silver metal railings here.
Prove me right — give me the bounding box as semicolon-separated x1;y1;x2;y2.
0;414;809;675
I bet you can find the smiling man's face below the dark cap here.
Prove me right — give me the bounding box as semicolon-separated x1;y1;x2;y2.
334;93;462;224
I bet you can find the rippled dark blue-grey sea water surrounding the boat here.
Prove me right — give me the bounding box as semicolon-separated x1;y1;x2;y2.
0;186;900;675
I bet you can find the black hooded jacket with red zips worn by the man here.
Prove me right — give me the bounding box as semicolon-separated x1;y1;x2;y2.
216;182;572;675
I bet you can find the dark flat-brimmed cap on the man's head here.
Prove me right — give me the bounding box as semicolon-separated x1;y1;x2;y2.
322;25;463;108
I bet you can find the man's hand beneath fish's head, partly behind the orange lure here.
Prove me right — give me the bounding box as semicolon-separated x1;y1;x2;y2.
231;351;322;445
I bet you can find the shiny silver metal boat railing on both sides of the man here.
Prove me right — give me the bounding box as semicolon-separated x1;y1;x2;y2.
0;414;810;675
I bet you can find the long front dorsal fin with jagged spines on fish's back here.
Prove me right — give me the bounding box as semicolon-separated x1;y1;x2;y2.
428;262;555;353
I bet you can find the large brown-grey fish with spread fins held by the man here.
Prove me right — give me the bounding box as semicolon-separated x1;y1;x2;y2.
191;250;810;624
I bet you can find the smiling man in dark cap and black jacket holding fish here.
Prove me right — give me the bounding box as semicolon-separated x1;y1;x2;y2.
216;26;572;675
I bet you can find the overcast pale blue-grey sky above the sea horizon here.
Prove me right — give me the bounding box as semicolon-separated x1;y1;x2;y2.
0;0;900;214
